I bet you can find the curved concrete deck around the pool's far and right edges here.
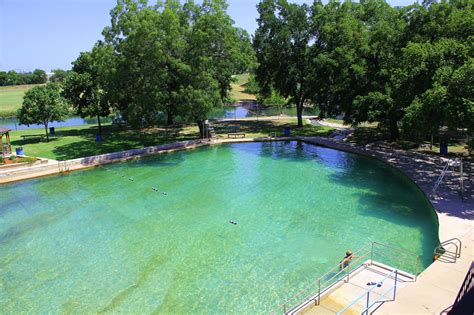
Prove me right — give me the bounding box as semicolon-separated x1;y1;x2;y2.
0;137;474;314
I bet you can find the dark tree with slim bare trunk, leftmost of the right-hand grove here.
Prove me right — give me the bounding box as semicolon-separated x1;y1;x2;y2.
253;0;312;127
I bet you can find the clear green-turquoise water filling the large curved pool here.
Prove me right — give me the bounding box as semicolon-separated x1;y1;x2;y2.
0;142;438;314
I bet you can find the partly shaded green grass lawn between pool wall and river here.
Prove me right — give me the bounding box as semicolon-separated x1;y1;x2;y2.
7;119;331;160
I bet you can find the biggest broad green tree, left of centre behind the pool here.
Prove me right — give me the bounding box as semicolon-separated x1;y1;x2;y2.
103;0;253;135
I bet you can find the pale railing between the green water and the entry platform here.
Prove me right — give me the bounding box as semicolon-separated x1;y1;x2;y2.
272;242;419;314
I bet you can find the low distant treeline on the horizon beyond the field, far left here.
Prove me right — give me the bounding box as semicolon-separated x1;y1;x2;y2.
0;69;67;86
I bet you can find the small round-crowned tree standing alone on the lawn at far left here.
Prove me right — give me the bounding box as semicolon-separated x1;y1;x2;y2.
17;83;68;141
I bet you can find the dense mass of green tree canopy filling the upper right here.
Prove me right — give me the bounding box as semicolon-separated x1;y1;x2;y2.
254;0;474;139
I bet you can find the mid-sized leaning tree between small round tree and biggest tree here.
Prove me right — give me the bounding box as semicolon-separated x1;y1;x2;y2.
63;44;111;135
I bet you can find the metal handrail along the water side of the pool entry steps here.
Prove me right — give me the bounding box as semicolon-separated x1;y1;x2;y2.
276;242;419;314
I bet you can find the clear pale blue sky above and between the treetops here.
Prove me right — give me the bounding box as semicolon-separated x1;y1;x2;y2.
0;0;415;72
